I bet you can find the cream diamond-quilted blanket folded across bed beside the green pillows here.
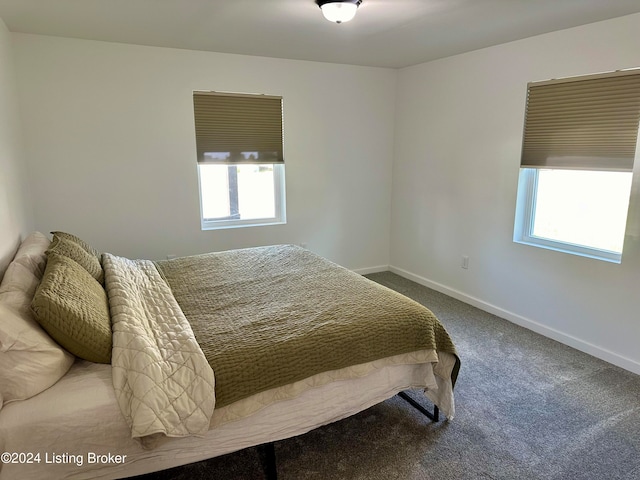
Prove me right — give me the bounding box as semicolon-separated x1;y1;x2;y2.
103;253;215;438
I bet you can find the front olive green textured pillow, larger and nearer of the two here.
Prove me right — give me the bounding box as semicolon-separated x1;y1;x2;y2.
31;252;111;363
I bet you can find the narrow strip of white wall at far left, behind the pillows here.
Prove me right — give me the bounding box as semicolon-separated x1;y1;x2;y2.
0;19;31;279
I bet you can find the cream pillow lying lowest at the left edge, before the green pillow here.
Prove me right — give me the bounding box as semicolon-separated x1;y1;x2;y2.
0;303;74;408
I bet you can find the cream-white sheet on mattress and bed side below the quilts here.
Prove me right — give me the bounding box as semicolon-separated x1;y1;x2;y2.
0;351;455;480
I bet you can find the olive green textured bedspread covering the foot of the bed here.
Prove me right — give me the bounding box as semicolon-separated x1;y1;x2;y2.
156;245;459;408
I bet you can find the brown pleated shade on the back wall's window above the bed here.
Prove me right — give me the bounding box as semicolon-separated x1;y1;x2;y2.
193;92;284;164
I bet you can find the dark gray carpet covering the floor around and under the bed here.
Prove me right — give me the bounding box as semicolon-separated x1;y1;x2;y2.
130;272;640;480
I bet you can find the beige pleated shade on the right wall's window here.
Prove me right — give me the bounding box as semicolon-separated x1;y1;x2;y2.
521;70;640;171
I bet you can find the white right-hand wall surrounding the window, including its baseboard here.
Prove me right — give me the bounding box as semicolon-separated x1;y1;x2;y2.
391;10;640;373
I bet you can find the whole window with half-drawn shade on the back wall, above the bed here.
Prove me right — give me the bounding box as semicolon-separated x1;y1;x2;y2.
193;92;286;230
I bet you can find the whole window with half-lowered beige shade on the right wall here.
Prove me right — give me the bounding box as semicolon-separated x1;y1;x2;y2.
514;70;640;263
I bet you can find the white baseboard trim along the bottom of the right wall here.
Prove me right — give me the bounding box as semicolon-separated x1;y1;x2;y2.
388;265;640;375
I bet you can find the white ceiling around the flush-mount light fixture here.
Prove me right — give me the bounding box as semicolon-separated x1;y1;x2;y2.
0;0;640;68
